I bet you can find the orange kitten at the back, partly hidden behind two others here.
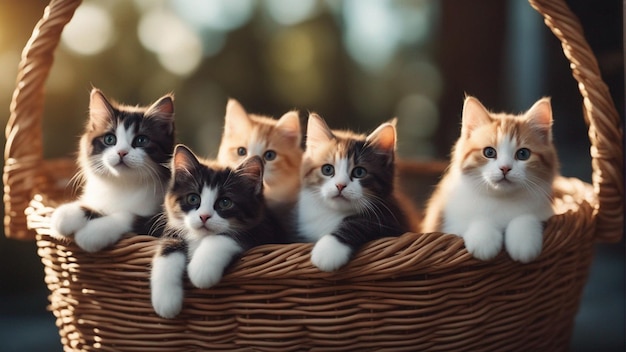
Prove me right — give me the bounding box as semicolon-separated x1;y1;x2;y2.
217;99;303;212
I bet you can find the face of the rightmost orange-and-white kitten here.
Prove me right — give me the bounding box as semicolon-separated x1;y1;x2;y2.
454;97;557;194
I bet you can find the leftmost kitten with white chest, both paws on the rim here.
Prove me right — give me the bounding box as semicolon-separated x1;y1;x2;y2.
51;88;174;252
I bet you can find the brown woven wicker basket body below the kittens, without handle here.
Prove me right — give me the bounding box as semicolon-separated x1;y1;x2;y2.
38;202;593;351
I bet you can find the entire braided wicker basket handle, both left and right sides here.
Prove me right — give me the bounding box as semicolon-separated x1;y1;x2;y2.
3;0;624;242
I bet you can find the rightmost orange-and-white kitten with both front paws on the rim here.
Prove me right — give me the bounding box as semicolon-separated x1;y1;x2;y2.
422;97;558;263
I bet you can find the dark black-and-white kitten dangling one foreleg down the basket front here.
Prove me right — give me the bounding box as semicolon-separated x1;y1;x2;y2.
150;145;285;318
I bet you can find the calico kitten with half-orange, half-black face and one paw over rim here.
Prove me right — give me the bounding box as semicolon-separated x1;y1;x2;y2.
296;114;409;271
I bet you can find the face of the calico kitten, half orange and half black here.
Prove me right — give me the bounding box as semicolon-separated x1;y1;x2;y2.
302;114;396;214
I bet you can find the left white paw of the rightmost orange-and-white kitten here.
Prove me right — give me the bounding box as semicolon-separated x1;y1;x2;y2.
463;222;502;260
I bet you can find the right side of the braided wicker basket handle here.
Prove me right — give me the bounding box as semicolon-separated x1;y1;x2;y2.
529;0;624;242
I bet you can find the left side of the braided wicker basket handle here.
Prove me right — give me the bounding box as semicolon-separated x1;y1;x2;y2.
3;0;81;240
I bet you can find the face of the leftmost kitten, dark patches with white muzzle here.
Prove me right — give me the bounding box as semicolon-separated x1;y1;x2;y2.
80;88;174;180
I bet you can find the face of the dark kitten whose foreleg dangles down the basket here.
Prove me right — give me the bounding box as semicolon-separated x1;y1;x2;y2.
165;145;264;238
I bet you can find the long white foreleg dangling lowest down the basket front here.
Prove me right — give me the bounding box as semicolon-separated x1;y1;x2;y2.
150;253;187;319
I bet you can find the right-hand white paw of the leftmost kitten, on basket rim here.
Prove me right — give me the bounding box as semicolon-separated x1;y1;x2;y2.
74;216;127;253
